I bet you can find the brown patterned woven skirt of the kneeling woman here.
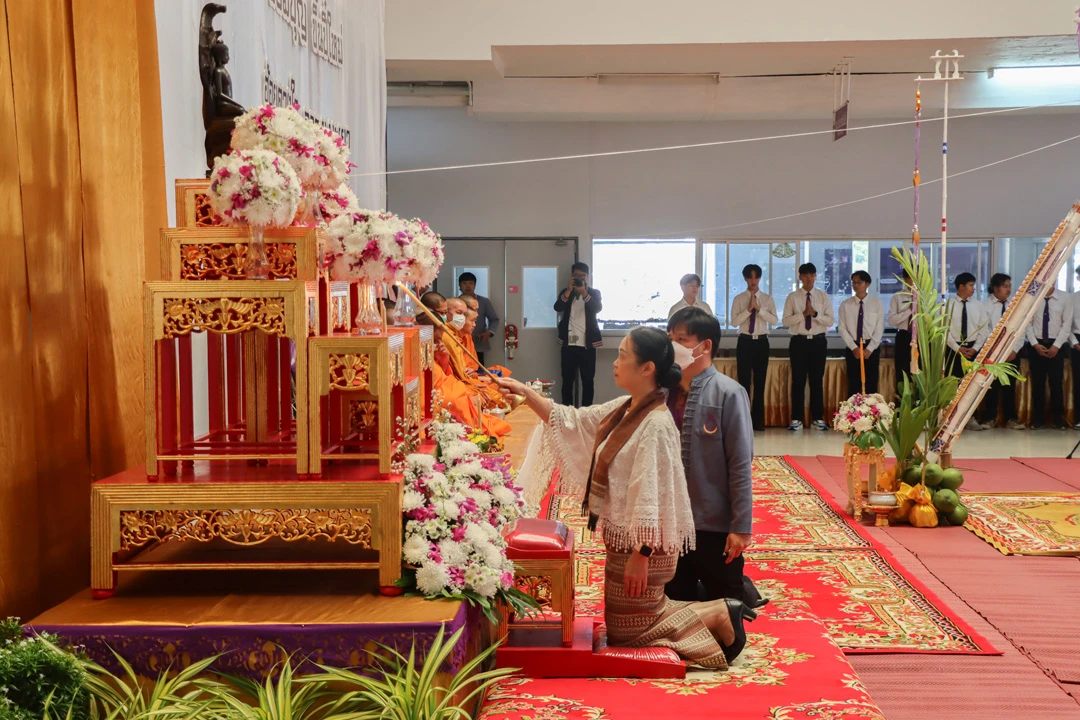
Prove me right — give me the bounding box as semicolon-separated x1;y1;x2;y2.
604;549;728;669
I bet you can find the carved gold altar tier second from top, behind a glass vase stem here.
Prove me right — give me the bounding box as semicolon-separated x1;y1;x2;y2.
160;228;319;282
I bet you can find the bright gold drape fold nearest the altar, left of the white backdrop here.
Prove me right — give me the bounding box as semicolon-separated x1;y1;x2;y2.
71;0;167;479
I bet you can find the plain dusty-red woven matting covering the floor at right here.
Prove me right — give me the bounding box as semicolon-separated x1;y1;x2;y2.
796;457;1080;720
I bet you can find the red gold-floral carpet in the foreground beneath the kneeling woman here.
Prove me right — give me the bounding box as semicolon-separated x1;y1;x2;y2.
480;602;885;720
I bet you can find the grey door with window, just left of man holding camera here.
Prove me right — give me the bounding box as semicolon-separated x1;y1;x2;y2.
505;237;578;398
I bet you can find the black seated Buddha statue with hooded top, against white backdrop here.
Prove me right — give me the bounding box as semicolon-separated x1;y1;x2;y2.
199;2;244;176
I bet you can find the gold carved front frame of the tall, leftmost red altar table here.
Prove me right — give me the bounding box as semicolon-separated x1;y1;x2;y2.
144;281;308;477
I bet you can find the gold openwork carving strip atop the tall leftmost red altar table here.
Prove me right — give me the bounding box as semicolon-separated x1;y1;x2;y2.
162;298;285;339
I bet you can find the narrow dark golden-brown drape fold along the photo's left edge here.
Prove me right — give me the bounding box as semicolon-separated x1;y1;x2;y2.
0;0;38;617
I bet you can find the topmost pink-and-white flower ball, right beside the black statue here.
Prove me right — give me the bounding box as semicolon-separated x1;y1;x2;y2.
232;104;326;190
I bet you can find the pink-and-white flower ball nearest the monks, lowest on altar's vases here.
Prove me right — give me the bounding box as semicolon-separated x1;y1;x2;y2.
322;209;444;285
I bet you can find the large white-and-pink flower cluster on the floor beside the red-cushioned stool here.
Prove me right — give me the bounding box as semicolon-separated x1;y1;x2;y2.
402;421;537;620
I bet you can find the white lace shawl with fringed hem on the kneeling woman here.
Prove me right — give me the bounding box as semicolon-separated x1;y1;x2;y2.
518;397;694;553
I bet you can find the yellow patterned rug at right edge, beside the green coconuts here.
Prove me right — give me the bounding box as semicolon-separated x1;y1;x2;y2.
963;492;1080;556
